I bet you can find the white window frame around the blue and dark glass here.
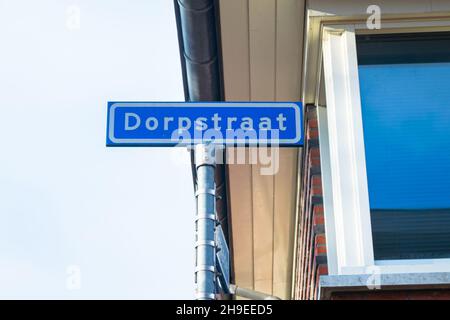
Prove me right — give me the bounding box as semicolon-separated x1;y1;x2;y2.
318;17;450;275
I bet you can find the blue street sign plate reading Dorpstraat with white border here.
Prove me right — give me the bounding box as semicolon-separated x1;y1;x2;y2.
106;102;303;147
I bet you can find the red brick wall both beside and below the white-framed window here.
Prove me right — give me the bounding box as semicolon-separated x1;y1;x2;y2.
293;106;450;300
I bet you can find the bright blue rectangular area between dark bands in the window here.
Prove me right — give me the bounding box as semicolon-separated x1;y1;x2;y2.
359;63;450;209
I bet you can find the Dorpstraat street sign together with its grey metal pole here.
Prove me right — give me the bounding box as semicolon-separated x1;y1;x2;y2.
106;102;303;300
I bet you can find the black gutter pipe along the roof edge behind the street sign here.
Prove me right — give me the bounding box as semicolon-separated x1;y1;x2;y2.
174;0;229;243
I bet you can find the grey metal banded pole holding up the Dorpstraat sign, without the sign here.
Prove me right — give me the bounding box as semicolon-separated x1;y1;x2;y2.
194;143;217;300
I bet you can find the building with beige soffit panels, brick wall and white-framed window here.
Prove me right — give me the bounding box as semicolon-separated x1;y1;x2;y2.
175;0;450;299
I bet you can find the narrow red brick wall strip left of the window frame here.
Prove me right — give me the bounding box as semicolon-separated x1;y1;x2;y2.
294;106;328;300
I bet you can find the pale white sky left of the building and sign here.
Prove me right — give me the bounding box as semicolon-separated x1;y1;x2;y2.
0;0;195;299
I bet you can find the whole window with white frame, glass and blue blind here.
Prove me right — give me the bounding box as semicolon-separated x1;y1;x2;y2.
319;18;450;274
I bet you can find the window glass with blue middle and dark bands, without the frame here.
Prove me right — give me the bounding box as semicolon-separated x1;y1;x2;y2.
356;32;450;260
